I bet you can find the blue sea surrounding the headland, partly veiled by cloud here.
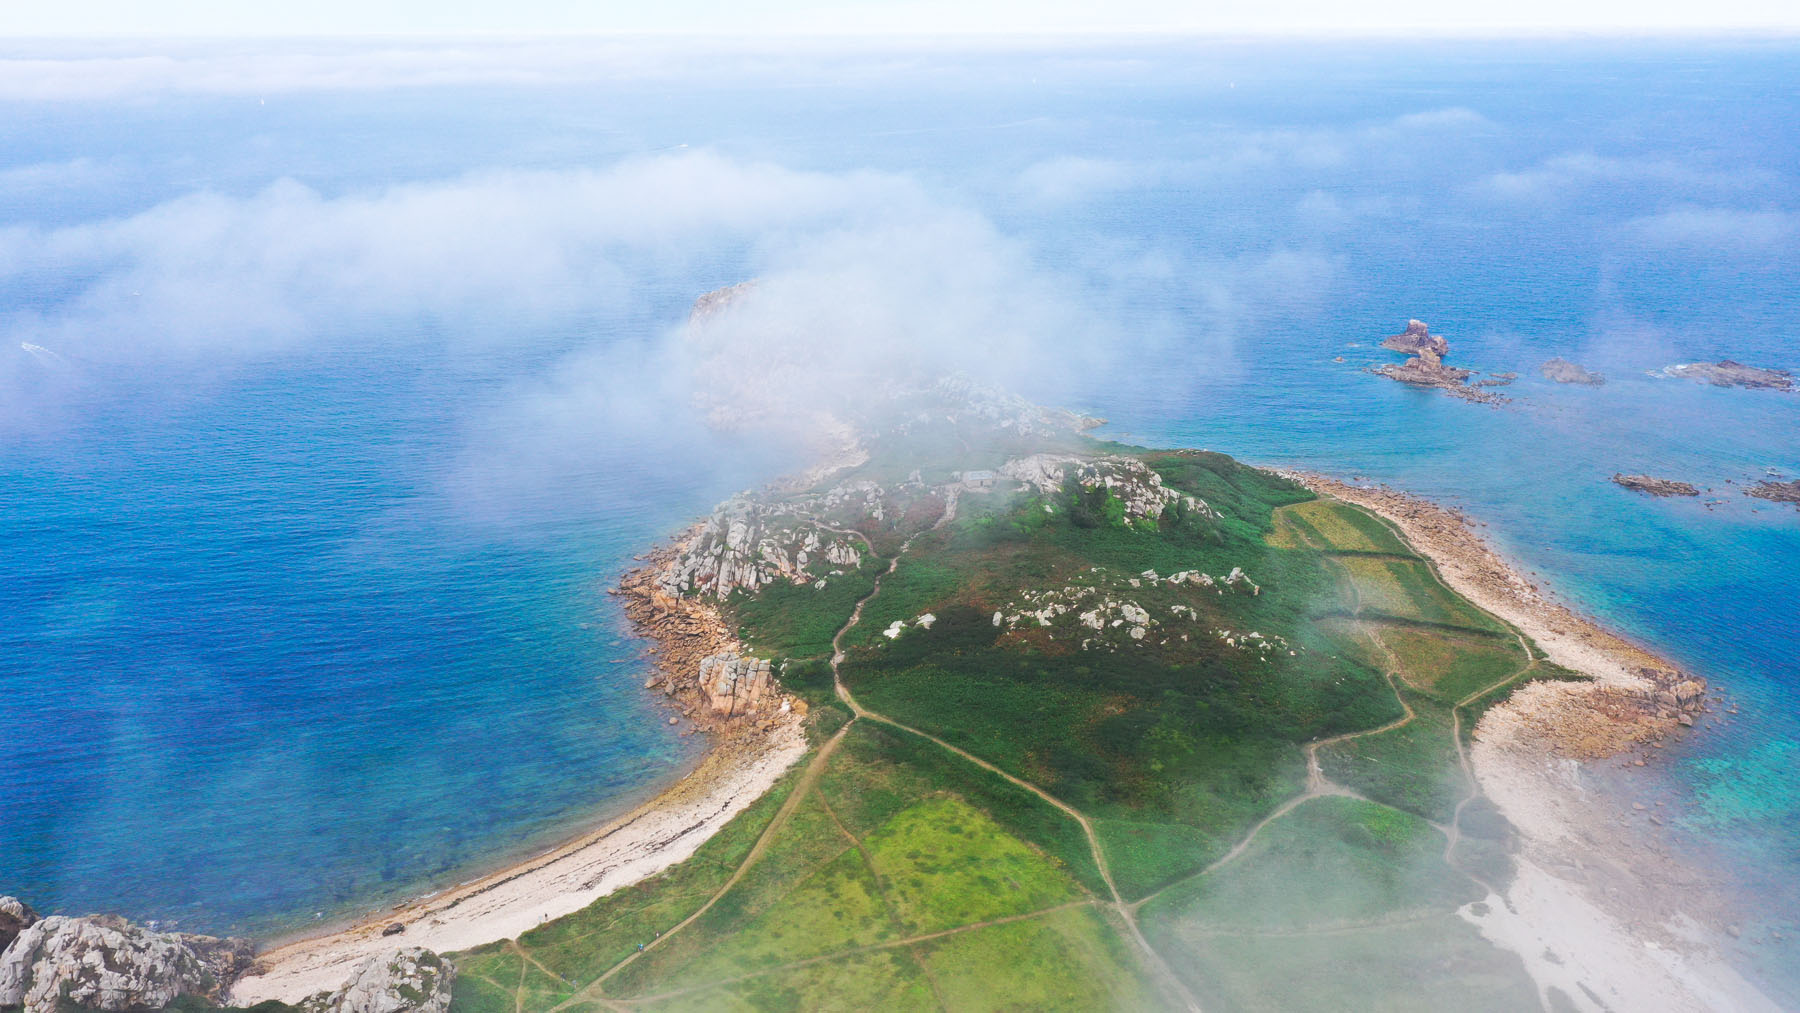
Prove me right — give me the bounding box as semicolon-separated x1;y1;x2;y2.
0;38;1800;1002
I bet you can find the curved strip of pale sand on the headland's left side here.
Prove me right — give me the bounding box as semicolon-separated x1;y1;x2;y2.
230;718;806;1006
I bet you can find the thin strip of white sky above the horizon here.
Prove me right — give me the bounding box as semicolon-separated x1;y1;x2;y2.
0;0;1800;36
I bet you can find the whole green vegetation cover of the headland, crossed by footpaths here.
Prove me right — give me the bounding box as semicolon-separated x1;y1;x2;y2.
442;430;1557;1013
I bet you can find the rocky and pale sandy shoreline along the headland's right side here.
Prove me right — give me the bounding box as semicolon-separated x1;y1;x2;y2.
1282;471;1778;1011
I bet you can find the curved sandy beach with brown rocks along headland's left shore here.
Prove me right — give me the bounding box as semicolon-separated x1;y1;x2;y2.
229;547;806;1006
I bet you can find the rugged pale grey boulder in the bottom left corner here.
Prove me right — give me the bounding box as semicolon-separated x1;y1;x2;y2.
0;916;252;1013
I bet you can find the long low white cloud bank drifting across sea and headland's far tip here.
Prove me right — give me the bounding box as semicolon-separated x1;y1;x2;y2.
0;151;1152;467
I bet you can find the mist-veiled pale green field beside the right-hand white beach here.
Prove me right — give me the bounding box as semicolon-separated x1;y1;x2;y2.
1141;797;1535;1009
